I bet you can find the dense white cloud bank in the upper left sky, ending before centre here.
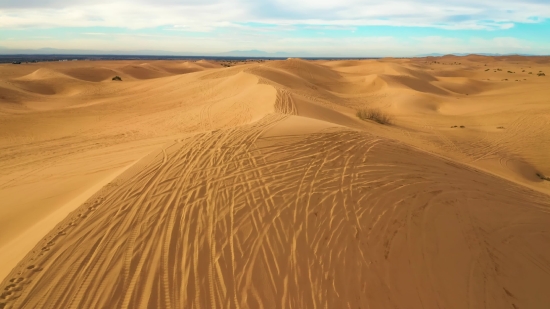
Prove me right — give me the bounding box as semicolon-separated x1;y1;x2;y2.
0;1;245;31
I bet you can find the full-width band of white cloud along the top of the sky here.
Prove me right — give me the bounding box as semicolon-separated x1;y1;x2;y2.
0;0;550;31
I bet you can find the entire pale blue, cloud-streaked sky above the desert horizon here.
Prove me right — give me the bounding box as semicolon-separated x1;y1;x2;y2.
0;0;550;57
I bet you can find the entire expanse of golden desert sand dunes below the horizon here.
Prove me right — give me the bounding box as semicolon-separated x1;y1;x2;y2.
0;55;550;309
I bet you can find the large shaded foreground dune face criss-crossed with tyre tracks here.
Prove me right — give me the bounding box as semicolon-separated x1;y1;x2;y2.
0;114;550;308
